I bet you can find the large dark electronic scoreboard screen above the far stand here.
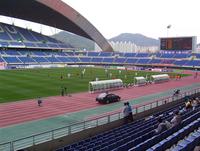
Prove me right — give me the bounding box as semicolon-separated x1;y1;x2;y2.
160;37;193;50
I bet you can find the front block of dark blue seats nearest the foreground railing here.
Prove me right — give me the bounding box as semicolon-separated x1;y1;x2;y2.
56;102;200;151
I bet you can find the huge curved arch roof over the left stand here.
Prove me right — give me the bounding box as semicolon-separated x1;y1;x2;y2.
0;0;113;51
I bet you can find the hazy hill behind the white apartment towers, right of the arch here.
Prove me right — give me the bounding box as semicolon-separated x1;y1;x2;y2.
109;33;159;46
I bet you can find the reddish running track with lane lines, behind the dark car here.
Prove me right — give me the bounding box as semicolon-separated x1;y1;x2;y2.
0;72;200;127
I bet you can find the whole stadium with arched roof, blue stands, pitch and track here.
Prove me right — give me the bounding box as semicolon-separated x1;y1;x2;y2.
0;0;200;151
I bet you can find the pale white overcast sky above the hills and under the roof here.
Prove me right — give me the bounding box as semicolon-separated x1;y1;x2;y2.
0;0;200;41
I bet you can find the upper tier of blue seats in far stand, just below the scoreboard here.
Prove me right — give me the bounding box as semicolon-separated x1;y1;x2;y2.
0;50;200;60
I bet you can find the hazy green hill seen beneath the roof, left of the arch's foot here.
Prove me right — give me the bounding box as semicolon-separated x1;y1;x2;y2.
52;31;94;50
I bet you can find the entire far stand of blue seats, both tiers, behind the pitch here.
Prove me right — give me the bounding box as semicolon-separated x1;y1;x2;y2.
0;48;200;68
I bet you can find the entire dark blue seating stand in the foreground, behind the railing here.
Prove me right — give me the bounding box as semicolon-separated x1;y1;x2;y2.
53;99;200;151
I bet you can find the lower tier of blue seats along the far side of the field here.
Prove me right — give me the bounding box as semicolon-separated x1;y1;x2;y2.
0;55;200;67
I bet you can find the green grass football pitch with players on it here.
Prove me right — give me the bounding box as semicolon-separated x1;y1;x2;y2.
0;68;186;103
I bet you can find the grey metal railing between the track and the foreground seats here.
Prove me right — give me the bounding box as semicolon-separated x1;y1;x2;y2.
0;88;200;151
